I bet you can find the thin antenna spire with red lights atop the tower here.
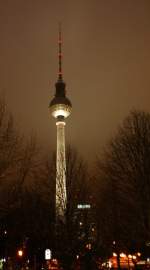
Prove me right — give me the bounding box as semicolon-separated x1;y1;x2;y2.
58;23;62;81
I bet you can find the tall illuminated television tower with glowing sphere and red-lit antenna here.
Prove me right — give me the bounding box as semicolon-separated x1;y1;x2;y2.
49;27;72;221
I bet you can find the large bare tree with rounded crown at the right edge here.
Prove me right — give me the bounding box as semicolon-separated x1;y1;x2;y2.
96;111;150;260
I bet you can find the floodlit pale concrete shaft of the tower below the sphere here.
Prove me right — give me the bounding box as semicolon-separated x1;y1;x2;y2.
56;120;67;220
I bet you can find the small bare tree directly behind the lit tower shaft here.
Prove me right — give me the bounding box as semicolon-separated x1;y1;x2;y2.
33;146;89;266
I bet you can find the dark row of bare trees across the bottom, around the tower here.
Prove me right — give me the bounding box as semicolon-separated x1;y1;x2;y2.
0;96;150;267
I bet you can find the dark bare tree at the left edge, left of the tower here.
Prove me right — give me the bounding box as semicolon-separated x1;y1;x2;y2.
0;98;42;264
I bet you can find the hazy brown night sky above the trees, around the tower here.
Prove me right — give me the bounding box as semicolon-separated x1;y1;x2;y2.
0;0;150;160
